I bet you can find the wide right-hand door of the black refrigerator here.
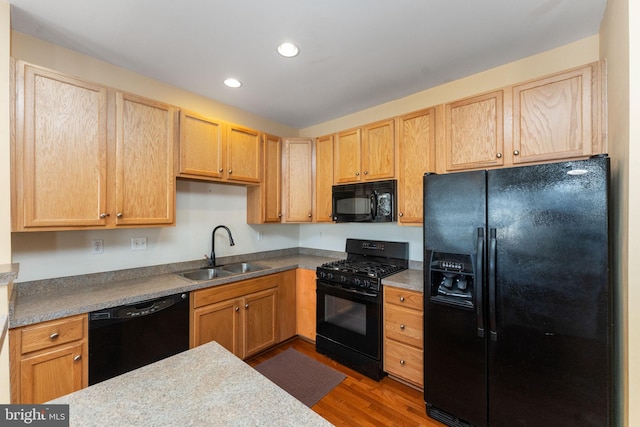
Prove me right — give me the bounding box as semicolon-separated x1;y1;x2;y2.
488;158;611;427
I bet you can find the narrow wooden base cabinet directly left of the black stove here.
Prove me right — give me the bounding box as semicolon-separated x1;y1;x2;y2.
296;268;316;341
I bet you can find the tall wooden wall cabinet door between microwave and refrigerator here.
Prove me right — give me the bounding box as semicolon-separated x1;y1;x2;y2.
398;108;436;225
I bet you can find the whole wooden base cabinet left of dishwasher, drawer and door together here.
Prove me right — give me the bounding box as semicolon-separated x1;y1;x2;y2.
9;315;89;404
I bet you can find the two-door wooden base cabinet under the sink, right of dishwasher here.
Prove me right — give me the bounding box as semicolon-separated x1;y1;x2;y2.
189;274;283;359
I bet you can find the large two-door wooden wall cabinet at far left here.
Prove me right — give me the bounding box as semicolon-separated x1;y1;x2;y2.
11;61;177;231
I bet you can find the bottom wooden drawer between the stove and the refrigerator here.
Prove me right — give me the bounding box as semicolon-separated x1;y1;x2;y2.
384;340;424;387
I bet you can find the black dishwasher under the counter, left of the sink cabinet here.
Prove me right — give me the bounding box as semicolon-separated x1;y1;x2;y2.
89;292;189;385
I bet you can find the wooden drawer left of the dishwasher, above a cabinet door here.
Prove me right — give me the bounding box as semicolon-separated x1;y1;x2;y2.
20;316;85;354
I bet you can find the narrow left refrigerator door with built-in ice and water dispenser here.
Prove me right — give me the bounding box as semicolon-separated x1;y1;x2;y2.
424;171;487;426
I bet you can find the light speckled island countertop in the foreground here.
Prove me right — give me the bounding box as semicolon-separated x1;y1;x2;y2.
50;342;331;427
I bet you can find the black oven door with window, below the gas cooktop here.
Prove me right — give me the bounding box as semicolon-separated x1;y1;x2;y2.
316;280;382;359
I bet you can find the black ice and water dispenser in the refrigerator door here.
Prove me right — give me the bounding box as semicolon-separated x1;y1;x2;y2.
429;252;474;309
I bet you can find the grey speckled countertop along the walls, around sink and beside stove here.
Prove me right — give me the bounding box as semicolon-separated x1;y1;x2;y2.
9;248;422;328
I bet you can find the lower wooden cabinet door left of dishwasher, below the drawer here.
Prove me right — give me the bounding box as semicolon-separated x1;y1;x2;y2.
20;343;86;404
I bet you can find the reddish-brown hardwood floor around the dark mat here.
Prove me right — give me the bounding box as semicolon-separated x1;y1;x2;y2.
247;338;444;427
